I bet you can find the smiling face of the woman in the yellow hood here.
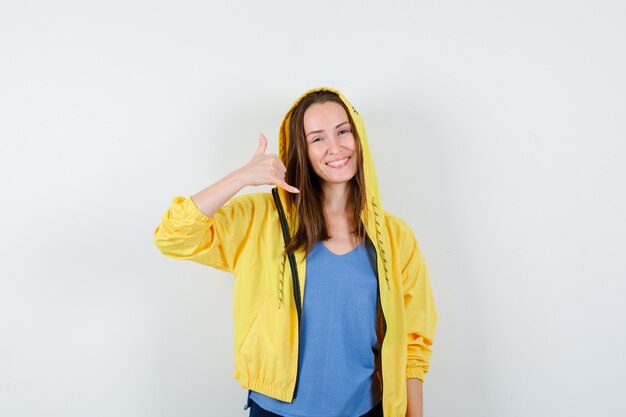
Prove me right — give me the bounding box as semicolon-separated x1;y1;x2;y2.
304;101;357;183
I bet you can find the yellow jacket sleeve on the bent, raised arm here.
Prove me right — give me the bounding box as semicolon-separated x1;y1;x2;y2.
154;195;254;272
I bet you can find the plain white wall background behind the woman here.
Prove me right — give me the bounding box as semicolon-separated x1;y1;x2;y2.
0;0;626;417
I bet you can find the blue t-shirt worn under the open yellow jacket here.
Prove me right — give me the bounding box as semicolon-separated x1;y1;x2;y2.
250;241;381;417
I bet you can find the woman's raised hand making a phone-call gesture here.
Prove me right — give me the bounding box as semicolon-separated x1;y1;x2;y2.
238;133;300;193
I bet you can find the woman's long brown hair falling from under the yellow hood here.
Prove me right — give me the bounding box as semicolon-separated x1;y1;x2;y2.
285;91;366;254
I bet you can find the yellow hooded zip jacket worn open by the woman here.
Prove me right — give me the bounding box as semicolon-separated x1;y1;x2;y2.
154;88;437;417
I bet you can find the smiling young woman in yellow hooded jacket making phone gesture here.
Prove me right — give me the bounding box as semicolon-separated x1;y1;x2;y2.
154;88;437;417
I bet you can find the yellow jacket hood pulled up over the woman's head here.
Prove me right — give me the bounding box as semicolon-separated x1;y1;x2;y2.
278;87;389;285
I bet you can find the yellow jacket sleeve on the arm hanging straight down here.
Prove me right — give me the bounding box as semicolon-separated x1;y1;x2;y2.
402;224;437;381
